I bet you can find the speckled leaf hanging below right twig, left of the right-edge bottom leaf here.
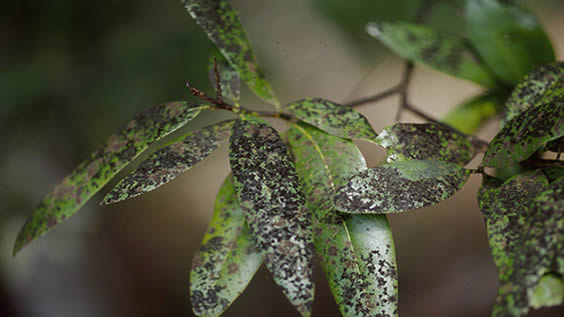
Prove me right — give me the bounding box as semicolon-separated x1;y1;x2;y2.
478;170;548;280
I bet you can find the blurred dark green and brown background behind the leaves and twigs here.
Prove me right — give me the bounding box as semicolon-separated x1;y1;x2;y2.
0;0;564;317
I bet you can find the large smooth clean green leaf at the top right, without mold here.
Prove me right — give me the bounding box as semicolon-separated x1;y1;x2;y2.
466;0;555;86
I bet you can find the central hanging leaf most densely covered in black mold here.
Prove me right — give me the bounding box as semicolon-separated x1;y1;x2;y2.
229;116;314;316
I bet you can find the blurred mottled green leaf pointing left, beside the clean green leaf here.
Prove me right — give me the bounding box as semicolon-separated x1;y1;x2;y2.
366;22;496;87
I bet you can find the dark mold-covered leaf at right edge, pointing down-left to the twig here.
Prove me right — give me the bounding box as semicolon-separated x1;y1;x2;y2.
482;94;564;167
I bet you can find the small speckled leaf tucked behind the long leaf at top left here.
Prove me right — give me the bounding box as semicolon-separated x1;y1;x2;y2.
208;52;241;102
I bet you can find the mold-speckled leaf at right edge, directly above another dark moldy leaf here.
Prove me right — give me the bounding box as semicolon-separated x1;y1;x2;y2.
505;62;564;122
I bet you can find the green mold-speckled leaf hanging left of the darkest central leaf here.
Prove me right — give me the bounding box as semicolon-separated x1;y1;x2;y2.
190;175;263;316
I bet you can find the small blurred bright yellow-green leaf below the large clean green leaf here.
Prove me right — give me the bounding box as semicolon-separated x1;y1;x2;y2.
442;93;506;134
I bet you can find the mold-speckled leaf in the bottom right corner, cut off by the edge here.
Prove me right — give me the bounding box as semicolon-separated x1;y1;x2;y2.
492;178;564;316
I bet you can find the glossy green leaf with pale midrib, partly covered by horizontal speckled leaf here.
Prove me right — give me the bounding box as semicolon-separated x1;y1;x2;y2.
288;123;398;317
